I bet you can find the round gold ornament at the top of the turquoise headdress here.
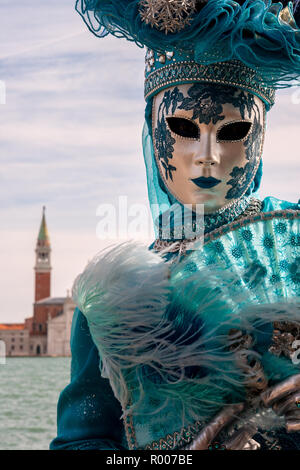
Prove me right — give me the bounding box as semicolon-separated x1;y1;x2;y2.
140;0;206;34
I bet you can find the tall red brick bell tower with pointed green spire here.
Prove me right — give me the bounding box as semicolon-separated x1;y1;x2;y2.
34;206;51;302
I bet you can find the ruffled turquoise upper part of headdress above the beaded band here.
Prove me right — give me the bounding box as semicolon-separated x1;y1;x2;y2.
76;0;300;88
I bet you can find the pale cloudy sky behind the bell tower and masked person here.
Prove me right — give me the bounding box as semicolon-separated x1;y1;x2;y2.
0;0;300;322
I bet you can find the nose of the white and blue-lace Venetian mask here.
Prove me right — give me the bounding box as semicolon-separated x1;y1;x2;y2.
194;132;220;170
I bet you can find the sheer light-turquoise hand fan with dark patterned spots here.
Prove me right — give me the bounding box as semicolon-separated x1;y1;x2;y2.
173;211;300;304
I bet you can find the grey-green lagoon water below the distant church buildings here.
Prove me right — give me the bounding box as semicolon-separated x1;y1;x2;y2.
0;357;71;450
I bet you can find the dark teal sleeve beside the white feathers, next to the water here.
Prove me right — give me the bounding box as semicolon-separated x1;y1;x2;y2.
50;308;127;450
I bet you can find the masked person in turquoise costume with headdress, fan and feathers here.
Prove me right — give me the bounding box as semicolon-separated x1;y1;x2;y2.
51;0;300;450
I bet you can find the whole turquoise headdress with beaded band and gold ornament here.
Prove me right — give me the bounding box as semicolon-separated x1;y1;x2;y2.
76;0;300;108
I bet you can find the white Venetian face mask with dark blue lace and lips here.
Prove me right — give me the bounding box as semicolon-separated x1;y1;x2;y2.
152;84;265;213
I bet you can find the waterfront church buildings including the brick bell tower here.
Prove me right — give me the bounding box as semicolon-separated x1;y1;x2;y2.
0;207;75;356
